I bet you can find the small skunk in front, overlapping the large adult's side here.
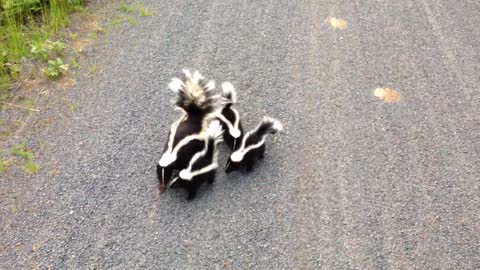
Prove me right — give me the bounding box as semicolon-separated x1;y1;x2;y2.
169;121;223;200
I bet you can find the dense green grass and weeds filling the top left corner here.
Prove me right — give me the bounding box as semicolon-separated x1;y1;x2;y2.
0;0;83;95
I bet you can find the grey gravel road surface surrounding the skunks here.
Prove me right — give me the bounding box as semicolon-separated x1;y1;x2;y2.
0;0;480;269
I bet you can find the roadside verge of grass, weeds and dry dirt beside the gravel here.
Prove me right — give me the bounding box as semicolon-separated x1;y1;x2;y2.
0;0;154;177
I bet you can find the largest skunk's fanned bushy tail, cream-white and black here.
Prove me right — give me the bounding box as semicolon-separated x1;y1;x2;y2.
168;70;216;115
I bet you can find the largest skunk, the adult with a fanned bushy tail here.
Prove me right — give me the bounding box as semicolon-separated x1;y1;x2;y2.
157;70;216;192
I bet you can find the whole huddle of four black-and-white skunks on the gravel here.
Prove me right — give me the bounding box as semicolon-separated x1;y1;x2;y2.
157;70;282;200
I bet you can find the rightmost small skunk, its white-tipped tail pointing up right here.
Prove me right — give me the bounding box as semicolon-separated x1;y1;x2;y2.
225;116;283;174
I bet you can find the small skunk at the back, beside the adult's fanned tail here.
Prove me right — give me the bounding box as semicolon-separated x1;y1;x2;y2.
215;82;243;150
